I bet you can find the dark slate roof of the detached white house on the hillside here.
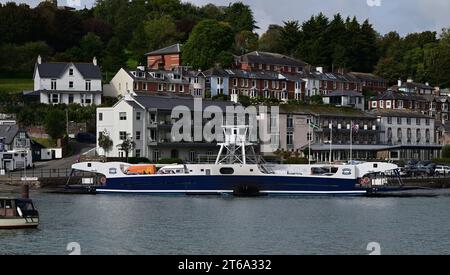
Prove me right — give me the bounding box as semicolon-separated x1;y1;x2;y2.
37;62;102;79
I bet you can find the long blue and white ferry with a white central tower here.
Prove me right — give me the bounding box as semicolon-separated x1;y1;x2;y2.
72;126;401;196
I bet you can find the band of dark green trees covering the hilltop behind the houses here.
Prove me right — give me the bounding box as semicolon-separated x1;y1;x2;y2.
0;0;450;87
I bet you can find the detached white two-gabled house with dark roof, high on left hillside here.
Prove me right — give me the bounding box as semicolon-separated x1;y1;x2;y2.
33;56;102;106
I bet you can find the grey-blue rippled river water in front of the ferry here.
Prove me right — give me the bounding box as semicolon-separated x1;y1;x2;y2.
0;190;450;255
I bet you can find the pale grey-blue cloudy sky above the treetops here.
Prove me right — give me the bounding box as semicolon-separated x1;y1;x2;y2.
0;0;450;35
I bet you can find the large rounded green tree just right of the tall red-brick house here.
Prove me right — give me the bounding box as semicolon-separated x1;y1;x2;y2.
183;19;234;70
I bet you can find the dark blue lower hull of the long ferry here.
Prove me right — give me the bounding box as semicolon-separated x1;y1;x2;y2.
96;175;367;195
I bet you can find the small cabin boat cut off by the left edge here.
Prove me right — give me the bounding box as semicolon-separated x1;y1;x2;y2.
0;198;39;229
